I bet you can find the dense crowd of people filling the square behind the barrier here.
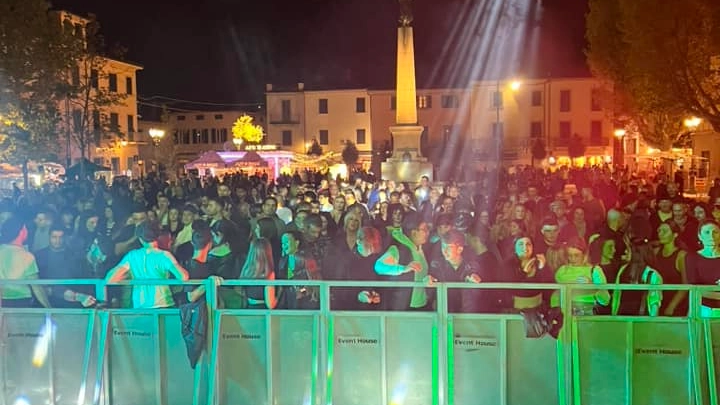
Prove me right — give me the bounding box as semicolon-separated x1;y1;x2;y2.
0;167;720;316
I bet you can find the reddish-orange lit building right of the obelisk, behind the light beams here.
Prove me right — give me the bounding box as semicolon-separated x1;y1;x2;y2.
471;78;615;164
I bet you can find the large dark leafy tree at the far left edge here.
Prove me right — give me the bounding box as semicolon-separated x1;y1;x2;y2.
0;0;74;187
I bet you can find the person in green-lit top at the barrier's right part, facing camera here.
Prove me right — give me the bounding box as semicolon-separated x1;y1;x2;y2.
550;238;610;315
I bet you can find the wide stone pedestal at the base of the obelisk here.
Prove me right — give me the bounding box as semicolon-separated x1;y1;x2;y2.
381;125;433;180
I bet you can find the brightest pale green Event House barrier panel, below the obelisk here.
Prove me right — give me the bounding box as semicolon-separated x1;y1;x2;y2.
328;312;438;405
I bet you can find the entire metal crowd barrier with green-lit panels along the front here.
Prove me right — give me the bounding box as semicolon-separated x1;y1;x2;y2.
0;280;720;405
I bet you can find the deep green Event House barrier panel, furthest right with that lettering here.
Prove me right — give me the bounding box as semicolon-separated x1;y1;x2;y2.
566;286;698;405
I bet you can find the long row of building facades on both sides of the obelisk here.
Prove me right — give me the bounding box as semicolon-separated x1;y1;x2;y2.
266;78;615;175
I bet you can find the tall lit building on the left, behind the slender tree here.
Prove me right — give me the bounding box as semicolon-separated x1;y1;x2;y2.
55;11;143;174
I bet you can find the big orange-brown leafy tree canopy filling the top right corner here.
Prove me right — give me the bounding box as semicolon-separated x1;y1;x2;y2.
586;0;720;137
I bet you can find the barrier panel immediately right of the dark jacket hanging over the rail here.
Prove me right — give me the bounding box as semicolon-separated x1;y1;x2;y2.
210;281;324;405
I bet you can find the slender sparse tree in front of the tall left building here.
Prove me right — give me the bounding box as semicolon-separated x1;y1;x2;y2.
61;15;127;163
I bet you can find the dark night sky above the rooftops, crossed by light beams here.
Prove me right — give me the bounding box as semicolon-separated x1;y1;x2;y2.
52;0;588;103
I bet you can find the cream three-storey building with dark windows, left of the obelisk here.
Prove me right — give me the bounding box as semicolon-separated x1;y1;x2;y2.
266;83;373;161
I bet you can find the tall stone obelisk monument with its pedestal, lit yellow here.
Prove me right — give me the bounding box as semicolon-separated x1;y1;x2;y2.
382;0;433;183
